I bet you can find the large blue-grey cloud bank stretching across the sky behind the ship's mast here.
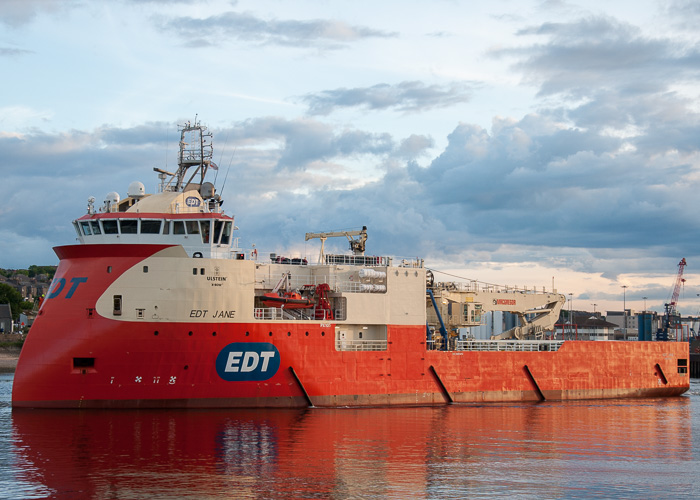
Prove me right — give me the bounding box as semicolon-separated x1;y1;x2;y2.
5;114;700;288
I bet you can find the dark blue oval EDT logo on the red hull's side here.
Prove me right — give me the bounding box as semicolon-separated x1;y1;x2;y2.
216;342;280;382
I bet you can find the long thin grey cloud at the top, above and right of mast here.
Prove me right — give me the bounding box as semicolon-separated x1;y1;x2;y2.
161;11;395;48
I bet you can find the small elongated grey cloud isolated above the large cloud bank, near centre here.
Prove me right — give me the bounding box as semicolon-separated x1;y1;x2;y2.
301;81;472;115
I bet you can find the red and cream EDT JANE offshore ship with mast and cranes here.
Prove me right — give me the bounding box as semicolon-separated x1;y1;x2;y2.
12;123;689;408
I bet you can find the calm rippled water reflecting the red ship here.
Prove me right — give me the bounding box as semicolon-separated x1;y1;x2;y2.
0;374;700;499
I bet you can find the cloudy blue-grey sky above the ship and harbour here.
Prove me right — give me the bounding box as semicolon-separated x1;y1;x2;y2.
0;0;700;314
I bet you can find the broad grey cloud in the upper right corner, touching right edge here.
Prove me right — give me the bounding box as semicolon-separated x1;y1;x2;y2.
493;17;700;98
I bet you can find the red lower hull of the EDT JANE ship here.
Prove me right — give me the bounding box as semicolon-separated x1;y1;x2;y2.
12;245;689;408
